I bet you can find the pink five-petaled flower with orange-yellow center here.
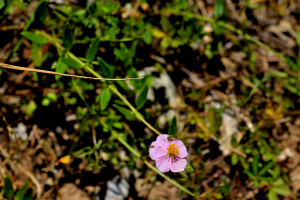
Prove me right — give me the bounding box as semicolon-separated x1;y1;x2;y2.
149;134;188;172
